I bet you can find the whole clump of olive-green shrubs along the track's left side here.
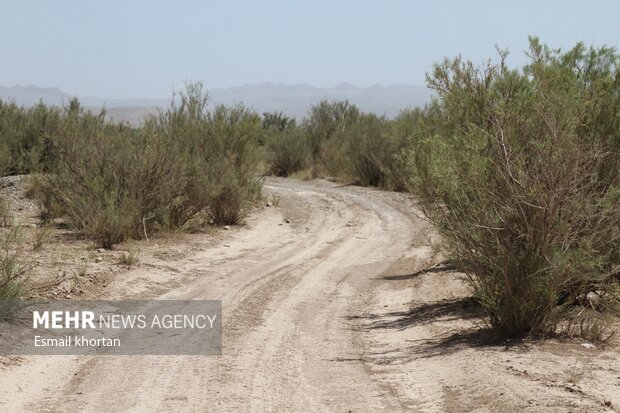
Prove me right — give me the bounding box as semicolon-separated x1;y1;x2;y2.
20;84;261;248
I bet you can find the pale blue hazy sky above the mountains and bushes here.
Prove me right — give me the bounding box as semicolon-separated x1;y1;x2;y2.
0;0;620;98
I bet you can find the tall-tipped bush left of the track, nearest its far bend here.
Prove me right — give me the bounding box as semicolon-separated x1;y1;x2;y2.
151;84;261;226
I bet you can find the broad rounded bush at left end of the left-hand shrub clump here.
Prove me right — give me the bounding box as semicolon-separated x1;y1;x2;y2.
35;102;153;248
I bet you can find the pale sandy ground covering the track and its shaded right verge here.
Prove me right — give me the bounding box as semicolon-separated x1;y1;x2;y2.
0;179;620;412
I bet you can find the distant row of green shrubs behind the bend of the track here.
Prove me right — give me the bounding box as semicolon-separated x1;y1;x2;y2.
263;101;424;190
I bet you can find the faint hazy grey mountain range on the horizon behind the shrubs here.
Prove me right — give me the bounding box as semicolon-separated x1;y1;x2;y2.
0;82;432;124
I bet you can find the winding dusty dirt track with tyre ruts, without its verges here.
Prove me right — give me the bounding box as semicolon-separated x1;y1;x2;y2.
0;175;426;412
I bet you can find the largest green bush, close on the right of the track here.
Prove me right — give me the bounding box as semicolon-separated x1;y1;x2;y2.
402;39;620;336
